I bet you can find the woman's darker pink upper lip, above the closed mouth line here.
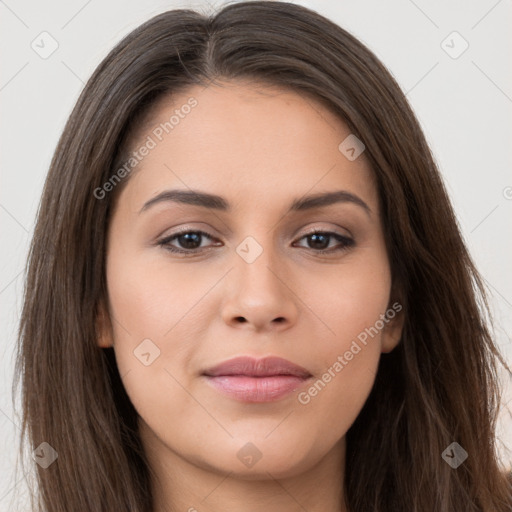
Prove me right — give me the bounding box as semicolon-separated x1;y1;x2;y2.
204;356;311;378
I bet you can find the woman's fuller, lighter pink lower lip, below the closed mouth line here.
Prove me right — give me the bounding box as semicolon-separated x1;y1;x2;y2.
206;375;308;403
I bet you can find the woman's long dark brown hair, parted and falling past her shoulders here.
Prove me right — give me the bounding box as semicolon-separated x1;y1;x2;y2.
14;1;512;512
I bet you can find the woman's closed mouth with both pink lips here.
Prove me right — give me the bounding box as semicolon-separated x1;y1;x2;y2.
203;357;312;403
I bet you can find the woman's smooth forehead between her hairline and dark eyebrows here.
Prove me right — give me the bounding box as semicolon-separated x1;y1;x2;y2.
122;82;376;216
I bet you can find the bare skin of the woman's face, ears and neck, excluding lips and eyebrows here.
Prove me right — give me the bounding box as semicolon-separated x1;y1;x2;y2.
98;82;403;512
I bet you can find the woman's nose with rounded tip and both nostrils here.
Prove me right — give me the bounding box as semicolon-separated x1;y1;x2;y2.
222;243;300;332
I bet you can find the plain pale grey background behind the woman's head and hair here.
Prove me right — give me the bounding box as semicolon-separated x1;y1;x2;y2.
0;0;512;511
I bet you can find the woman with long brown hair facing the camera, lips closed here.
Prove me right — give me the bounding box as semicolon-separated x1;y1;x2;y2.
13;2;512;512
